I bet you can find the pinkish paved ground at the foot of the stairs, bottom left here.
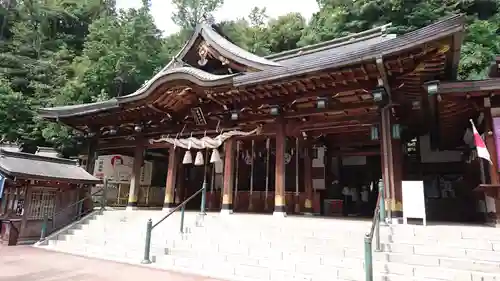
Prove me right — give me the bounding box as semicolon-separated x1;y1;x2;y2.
0;246;220;281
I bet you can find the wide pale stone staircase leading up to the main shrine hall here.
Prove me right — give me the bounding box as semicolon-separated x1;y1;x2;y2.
37;210;500;281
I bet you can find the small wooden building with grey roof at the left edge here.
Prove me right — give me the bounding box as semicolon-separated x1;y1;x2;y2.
0;149;101;245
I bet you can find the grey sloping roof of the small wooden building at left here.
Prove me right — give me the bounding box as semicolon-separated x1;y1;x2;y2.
0;149;101;184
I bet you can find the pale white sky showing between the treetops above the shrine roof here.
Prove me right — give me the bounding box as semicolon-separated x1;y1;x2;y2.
116;0;318;35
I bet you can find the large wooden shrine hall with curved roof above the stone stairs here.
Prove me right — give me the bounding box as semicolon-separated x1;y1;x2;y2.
40;15;498;223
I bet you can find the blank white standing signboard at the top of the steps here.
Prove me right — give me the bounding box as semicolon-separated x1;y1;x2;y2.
402;181;427;225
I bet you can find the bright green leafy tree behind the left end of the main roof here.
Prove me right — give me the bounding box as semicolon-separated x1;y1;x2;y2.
58;2;164;104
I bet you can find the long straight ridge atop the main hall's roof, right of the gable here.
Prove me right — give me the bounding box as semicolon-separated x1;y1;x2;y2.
264;23;392;61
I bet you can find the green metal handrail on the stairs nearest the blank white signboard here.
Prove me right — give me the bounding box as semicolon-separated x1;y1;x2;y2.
364;181;385;281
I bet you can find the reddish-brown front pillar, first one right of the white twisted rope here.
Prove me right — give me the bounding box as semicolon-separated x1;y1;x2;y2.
273;120;286;217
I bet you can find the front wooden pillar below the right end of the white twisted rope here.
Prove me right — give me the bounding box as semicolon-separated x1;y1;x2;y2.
221;139;237;214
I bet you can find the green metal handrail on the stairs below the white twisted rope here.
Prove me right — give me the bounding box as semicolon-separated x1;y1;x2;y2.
141;182;207;264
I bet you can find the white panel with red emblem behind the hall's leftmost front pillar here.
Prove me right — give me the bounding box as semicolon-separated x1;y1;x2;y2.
94;154;153;185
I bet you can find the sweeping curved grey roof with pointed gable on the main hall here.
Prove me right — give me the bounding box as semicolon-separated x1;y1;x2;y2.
39;15;465;119
